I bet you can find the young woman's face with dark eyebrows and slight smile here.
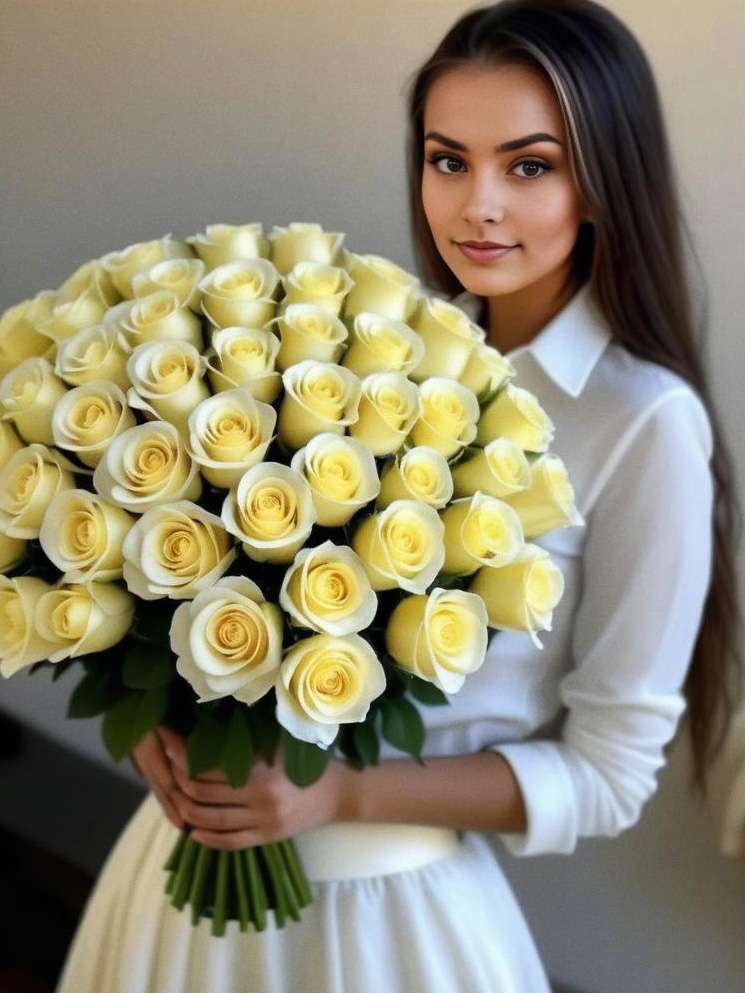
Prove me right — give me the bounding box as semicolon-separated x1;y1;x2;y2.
422;66;586;297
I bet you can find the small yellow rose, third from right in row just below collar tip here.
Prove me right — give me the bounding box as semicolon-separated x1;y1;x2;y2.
349;372;421;455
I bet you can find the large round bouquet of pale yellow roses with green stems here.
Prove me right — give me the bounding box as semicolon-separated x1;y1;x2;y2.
0;223;582;934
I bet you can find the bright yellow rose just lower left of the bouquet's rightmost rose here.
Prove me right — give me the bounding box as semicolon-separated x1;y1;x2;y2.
440;493;525;576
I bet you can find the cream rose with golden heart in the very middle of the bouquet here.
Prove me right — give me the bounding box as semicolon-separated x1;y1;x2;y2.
221;462;318;563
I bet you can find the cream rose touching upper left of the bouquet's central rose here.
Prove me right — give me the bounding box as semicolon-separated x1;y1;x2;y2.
186;389;277;489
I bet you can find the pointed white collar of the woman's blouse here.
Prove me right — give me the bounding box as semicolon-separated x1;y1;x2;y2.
452;283;613;397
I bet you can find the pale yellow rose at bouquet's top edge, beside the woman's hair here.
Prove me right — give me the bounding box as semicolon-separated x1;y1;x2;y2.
344;252;421;322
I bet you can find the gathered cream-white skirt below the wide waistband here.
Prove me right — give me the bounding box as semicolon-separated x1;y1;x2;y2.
57;794;550;993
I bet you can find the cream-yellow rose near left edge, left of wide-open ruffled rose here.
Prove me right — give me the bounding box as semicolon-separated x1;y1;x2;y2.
39;490;136;583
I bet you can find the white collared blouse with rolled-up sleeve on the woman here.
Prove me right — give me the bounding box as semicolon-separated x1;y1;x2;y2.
381;284;714;855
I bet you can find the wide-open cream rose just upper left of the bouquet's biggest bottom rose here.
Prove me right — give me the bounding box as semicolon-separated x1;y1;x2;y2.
122;500;237;600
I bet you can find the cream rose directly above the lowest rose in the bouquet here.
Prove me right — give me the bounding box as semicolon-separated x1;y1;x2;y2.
279;541;378;636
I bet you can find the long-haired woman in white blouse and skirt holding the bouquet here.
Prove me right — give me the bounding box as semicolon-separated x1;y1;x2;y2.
55;0;738;993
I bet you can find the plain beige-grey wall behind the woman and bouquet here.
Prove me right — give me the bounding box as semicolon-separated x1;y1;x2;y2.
0;0;745;993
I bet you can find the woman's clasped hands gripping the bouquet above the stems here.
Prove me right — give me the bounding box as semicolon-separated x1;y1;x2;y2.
156;727;354;851
